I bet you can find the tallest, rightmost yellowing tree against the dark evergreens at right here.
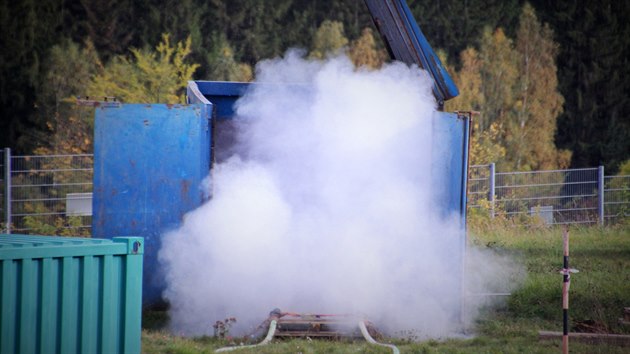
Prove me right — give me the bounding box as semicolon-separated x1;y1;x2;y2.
504;3;570;170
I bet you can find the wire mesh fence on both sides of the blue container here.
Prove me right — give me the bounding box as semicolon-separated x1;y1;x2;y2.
0;149;630;235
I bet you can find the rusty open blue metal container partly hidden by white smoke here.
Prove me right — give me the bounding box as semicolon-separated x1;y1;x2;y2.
92;81;469;306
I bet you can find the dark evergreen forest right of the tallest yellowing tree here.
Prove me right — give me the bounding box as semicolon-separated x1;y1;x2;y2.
535;0;630;173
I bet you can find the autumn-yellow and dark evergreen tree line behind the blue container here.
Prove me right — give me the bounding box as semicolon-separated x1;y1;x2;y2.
0;0;630;173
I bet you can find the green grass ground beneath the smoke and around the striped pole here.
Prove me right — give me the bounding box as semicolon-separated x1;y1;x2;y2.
142;222;630;353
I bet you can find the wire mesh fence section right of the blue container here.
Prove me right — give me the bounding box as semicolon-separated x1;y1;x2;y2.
468;164;630;224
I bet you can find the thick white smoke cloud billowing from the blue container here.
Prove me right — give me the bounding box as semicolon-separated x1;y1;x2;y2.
160;51;520;336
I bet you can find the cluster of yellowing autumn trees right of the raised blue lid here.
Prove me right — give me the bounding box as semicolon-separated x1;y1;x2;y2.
446;4;571;170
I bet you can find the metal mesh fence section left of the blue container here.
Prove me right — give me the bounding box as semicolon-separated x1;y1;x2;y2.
2;149;93;235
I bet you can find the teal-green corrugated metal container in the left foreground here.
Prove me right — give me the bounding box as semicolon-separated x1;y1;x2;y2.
0;235;144;353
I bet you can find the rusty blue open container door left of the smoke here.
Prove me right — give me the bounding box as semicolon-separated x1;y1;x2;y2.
92;104;212;306
